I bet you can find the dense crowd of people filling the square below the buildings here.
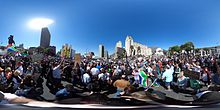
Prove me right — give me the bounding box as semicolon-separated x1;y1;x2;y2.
0;51;220;100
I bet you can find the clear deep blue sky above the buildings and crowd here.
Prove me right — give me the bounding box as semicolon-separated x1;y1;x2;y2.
0;0;220;54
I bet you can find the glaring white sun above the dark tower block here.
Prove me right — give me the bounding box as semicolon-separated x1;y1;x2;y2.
28;18;54;30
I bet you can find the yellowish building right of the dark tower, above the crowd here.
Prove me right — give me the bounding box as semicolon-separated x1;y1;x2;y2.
61;44;75;59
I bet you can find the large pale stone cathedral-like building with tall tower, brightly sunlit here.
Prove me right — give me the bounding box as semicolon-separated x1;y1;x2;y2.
125;36;152;56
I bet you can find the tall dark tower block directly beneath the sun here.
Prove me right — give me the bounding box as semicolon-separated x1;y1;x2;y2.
40;27;51;48
